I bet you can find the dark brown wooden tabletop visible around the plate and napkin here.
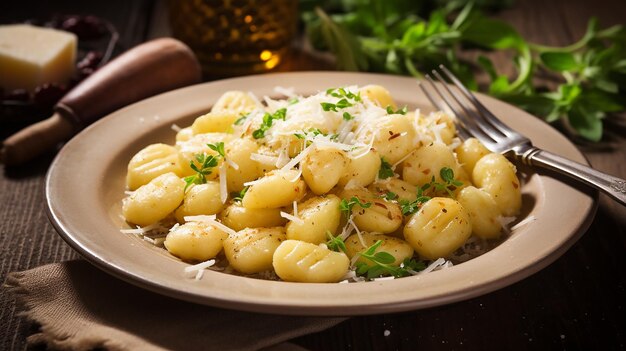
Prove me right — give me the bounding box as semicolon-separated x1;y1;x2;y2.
0;0;626;350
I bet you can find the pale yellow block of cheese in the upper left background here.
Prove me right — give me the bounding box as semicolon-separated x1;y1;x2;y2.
0;24;78;91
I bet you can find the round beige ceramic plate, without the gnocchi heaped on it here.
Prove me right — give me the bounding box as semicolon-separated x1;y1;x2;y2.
46;72;597;315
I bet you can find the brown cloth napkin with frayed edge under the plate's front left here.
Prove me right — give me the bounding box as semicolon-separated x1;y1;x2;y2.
5;260;345;350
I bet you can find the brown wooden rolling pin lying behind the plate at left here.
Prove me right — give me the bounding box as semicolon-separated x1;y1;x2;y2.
0;38;201;165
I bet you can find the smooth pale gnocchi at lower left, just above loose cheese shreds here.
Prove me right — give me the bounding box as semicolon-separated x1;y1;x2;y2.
164;222;228;261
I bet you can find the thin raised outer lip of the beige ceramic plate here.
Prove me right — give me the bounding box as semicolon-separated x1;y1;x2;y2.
45;71;598;316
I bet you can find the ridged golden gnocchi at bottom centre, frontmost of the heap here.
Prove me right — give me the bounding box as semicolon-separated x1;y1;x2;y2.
273;240;350;283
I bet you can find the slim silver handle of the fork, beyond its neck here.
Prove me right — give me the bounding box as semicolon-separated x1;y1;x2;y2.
525;148;626;205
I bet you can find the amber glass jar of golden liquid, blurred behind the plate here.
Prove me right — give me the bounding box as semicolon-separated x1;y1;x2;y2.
169;0;298;76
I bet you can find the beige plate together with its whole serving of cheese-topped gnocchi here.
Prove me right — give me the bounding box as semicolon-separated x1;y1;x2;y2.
46;72;597;316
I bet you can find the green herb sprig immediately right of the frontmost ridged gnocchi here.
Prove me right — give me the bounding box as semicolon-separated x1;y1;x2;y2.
356;240;426;279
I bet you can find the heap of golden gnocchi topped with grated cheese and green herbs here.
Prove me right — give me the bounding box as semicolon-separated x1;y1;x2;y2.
122;84;522;283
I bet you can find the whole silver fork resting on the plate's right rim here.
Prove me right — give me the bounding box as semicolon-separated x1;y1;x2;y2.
420;65;626;205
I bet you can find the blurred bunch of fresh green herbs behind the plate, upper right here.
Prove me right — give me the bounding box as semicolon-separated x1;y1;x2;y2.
300;0;626;141
